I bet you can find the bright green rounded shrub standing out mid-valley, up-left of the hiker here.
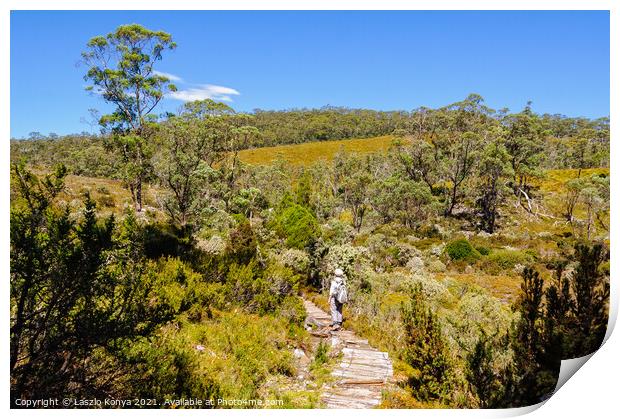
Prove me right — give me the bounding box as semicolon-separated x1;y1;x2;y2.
275;204;320;249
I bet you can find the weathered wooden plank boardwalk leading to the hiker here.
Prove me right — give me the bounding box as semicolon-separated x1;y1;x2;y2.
304;300;393;409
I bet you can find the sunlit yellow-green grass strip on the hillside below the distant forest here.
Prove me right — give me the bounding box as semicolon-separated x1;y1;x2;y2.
239;135;394;166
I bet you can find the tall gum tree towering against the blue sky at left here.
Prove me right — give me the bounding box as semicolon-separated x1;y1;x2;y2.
82;24;176;211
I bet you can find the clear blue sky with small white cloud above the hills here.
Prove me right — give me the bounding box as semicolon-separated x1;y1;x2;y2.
11;11;609;137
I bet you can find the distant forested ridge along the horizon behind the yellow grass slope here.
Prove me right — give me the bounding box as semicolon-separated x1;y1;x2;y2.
11;104;609;178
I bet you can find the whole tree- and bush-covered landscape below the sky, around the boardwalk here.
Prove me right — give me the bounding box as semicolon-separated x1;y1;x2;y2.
10;24;610;408
